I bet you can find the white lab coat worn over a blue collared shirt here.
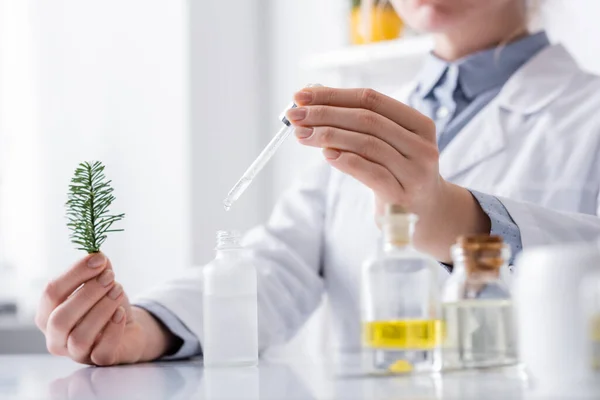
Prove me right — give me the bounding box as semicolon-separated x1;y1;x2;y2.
142;45;600;349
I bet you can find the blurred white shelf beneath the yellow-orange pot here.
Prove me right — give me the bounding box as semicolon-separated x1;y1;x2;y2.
301;35;433;71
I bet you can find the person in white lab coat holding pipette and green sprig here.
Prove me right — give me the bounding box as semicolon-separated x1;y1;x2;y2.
36;0;600;365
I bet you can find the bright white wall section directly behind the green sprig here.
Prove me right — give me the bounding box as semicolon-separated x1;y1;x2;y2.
2;0;191;316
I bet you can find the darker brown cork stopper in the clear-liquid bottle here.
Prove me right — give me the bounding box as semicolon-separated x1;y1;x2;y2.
456;235;505;276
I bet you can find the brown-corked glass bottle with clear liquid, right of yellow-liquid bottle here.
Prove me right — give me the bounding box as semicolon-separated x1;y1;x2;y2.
442;235;518;370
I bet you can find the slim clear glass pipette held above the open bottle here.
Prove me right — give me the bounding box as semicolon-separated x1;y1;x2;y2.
223;84;321;211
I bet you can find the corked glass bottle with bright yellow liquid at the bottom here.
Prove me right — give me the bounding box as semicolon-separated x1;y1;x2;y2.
361;205;442;373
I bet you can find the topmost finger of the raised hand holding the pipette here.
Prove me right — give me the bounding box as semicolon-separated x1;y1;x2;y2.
294;87;435;139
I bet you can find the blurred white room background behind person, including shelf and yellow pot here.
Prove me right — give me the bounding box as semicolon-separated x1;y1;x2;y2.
0;0;600;353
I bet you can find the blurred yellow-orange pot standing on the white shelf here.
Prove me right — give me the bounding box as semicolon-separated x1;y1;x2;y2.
350;2;404;44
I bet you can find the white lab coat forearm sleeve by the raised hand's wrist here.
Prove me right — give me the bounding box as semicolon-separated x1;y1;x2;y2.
498;197;600;249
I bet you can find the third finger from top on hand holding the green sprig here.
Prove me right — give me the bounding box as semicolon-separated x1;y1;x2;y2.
66;283;125;362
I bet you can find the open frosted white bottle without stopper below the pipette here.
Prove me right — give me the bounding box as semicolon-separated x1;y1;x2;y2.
202;231;258;367
